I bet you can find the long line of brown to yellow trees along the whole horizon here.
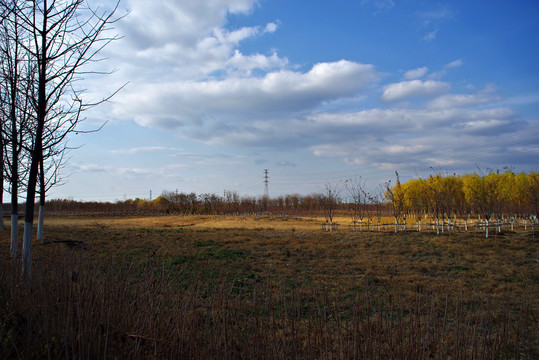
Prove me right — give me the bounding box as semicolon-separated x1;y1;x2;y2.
43;171;539;227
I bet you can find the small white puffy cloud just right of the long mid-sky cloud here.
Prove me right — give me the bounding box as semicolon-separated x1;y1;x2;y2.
382;80;451;102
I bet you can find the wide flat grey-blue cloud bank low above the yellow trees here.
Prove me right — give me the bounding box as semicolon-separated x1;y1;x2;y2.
304;108;530;170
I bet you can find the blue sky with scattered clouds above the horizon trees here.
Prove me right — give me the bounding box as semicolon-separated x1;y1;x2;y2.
48;0;539;201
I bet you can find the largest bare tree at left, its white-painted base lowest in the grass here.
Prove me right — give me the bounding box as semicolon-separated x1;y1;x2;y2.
5;0;123;278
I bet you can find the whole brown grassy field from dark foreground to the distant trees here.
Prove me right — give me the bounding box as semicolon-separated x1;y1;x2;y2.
0;216;539;359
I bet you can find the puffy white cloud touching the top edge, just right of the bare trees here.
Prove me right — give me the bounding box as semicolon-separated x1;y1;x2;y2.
104;0;288;83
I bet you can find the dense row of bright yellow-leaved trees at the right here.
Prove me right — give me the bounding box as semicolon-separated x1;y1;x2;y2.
386;171;539;236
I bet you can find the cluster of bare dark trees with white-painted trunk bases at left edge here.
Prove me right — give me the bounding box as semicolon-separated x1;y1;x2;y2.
0;0;122;278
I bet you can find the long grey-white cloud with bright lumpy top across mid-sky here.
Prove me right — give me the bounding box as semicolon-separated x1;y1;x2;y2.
115;60;379;128
